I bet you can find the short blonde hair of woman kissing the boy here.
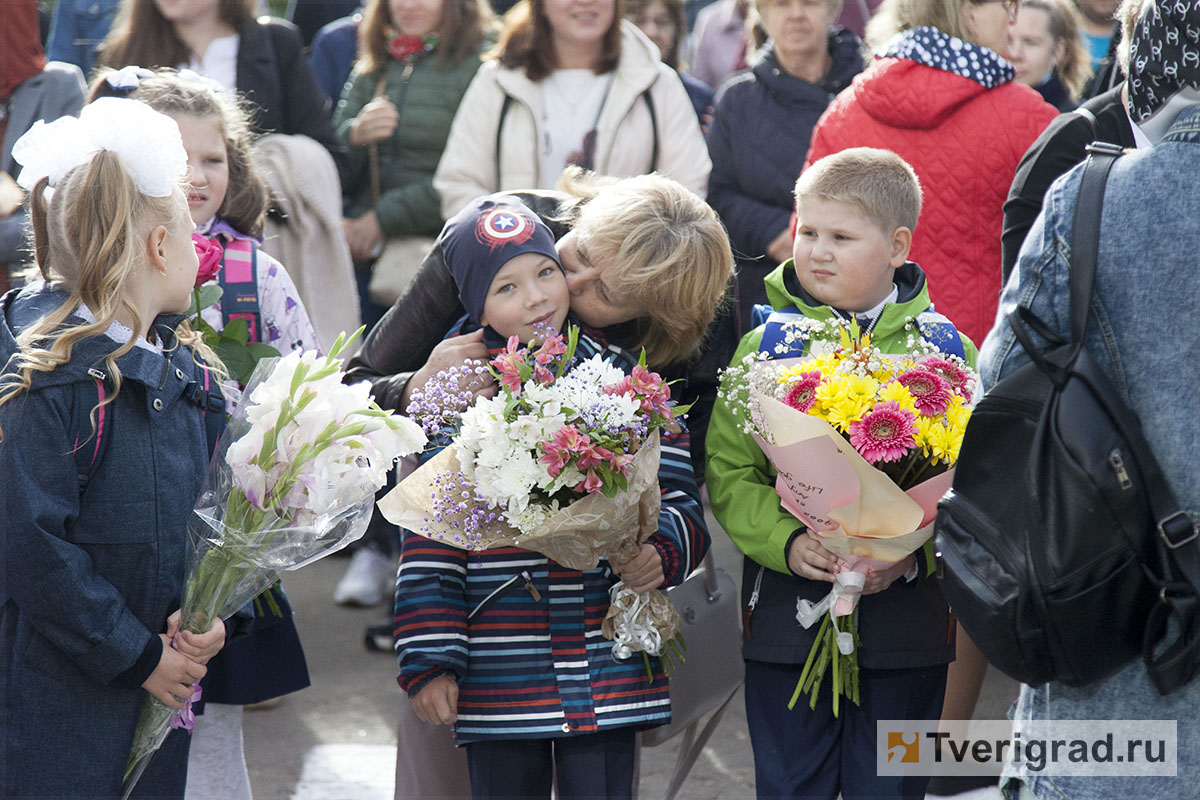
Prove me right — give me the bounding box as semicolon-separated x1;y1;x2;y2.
560;172;733;367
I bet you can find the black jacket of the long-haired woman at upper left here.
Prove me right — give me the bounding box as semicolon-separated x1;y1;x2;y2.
236;17;346;180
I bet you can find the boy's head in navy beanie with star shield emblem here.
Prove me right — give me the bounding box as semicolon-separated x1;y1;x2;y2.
438;194;570;348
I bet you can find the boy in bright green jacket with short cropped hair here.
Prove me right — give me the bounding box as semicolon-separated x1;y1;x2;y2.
708;148;977;800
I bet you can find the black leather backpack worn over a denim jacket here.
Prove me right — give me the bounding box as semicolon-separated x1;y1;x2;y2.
936;145;1200;694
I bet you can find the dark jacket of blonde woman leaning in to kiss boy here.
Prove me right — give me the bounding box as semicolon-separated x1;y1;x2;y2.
346;191;738;483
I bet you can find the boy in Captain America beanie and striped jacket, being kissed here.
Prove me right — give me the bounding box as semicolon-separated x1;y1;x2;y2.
395;196;709;798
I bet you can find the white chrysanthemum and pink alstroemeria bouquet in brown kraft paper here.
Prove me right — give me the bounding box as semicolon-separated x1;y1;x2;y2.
379;326;682;671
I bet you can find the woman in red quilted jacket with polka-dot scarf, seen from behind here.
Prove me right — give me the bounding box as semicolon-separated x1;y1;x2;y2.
808;0;1057;342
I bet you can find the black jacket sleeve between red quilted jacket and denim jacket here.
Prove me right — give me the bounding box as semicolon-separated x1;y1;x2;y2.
1001;85;1136;281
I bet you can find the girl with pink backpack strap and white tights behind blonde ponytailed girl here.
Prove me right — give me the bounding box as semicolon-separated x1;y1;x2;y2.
92;67;320;800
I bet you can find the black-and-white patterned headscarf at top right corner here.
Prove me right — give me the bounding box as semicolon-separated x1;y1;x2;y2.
1129;0;1200;124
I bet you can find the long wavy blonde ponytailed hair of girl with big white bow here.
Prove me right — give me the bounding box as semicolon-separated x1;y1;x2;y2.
0;150;222;439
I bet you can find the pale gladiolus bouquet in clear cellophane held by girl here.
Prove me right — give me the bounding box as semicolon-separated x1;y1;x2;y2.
121;329;426;798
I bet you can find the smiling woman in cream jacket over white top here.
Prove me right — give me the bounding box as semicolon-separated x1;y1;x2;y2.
433;0;710;217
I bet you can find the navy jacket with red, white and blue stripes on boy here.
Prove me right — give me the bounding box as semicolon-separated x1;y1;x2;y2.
395;331;709;744
